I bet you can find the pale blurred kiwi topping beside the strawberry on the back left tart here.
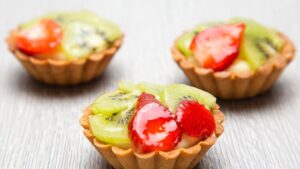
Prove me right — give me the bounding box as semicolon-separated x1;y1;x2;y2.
45;11;121;60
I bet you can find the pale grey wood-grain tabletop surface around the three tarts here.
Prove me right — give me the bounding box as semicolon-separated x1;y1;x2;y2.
0;0;300;169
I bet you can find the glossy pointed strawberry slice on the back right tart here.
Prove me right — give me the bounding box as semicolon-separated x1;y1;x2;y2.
190;23;246;71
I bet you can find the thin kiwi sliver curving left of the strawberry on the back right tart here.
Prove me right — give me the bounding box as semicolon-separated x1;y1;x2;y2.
176;22;221;56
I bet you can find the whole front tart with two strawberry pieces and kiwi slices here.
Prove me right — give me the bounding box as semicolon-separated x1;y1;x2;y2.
80;82;224;169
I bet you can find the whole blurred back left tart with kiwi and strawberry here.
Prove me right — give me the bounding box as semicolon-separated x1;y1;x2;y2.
7;11;123;85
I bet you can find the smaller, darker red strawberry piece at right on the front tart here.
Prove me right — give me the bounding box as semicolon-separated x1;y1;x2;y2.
176;100;216;140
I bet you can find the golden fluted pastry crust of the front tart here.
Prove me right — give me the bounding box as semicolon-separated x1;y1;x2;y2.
80;105;224;169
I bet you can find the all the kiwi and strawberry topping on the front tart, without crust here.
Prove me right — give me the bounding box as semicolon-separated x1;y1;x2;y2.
89;82;216;153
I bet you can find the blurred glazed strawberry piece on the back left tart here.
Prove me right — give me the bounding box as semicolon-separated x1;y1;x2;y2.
16;19;63;54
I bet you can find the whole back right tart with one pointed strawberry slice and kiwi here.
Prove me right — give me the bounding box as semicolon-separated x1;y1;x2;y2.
172;18;295;99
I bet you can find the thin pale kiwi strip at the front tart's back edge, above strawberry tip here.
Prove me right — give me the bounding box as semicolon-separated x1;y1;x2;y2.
118;81;164;100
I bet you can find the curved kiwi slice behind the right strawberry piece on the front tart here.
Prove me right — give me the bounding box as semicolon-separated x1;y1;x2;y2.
162;84;216;112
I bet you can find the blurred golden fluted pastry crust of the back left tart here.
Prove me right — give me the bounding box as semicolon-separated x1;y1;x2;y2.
7;30;124;86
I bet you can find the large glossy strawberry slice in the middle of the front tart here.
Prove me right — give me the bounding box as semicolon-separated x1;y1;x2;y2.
128;93;182;153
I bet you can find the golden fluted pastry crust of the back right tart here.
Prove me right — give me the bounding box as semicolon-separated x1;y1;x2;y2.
171;33;296;99
